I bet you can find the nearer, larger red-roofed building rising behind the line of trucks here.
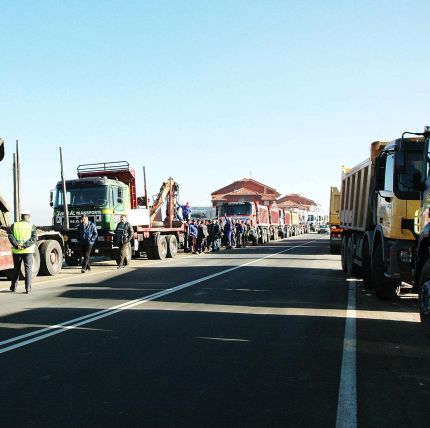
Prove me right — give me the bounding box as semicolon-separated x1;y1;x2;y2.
211;178;281;207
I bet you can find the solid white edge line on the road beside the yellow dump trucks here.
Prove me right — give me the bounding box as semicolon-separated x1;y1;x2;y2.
336;281;357;428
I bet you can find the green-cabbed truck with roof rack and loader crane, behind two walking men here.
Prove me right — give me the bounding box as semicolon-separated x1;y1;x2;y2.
51;161;184;266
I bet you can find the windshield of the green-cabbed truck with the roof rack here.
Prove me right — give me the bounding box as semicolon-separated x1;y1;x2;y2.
54;186;109;208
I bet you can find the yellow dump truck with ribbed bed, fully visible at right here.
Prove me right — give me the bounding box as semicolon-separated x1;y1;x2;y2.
339;137;426;299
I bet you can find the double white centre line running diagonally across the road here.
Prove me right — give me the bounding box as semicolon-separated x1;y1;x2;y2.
0;237;313;354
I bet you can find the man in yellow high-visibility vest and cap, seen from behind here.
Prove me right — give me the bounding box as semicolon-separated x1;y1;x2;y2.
9;211;37;294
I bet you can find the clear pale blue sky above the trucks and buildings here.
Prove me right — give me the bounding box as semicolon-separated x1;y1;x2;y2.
0;0;430;224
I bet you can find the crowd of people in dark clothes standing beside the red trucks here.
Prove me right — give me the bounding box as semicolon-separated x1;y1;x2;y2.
184;217;251;254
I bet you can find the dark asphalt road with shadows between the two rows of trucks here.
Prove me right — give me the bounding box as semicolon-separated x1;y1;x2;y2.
0;234;430;427
